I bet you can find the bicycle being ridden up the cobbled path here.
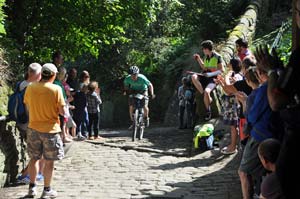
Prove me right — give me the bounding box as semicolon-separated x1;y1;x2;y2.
129;94;148;142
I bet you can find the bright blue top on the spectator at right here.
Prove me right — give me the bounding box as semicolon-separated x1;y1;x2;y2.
248;83;273;142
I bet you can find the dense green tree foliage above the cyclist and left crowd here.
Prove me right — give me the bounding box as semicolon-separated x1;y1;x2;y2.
1;0;241;123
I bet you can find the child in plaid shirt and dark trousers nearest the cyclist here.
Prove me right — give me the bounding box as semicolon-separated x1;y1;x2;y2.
86;81;102;140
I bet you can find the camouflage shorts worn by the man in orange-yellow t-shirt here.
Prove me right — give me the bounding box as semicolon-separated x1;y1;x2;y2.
27;128;64;160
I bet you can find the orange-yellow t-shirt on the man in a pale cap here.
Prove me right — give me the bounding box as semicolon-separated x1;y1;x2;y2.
24;82;65;133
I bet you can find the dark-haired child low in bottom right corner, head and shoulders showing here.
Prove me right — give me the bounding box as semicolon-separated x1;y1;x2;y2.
258;139;283;199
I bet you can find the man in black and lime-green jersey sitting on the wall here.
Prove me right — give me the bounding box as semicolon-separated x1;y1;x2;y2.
192;40;224;120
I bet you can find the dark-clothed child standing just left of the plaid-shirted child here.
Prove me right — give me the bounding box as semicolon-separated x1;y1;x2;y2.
73;84;88;140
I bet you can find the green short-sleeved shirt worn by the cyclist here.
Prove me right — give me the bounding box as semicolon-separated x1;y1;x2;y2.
124;74;151;91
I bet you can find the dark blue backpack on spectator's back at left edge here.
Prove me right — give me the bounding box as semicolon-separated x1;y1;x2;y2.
7;82;28;124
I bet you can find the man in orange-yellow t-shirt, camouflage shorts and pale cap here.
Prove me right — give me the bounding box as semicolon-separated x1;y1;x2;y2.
24;63;65;198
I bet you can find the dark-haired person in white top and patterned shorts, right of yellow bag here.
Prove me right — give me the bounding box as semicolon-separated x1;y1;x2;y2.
216;58;243;155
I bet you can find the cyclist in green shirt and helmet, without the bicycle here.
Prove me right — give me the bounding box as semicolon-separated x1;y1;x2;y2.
124;66;155;127
